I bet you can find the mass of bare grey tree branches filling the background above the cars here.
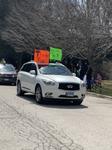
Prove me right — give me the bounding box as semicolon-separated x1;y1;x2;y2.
1;0;112;63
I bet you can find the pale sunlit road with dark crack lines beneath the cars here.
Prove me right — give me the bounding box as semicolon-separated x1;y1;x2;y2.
0;85;112;150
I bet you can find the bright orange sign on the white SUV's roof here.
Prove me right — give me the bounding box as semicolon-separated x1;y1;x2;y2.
34;49;49;64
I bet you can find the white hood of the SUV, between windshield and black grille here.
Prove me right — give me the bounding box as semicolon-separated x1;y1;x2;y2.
40;75;81;83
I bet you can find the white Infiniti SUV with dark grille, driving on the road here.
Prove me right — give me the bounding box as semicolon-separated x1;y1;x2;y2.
17;61;86;105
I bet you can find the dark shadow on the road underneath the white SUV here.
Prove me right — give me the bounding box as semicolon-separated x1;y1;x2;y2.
21;94;88;109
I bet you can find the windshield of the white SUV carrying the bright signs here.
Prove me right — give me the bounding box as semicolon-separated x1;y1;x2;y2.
39;65;72;76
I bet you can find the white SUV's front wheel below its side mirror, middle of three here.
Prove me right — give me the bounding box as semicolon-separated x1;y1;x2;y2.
35;85;43;104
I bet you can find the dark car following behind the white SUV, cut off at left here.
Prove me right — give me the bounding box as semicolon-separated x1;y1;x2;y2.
0;64;17;85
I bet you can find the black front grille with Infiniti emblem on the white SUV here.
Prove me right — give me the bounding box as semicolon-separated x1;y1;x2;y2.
59;83;80;91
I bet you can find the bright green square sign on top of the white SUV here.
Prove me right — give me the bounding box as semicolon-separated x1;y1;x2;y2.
50;47;62;61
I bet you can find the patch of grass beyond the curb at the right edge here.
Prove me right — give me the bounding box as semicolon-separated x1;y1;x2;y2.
91;80;112;96
